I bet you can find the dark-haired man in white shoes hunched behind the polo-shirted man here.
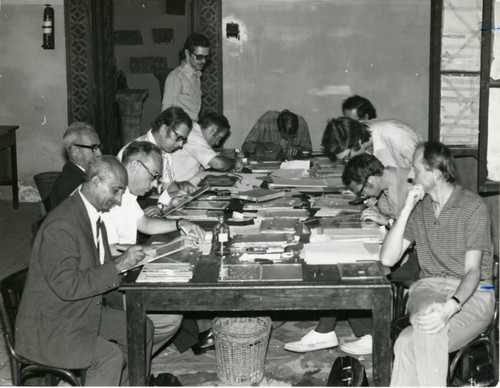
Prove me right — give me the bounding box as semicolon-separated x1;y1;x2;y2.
285;153;418;355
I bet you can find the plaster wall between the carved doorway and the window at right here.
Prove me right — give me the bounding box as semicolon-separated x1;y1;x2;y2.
222;0;430;150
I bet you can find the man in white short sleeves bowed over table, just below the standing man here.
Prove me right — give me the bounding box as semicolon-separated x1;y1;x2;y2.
172;112;243;181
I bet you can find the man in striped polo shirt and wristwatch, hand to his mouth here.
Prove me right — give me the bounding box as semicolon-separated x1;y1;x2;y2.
380;141;495;387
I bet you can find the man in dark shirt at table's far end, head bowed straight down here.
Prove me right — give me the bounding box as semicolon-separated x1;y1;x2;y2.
242;109;312;160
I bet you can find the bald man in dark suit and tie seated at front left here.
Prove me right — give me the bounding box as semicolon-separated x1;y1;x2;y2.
16;156;153;386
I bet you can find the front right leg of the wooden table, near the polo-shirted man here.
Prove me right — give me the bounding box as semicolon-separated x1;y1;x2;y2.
372;289;392;387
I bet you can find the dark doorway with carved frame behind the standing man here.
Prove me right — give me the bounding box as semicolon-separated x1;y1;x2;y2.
64;0;222;154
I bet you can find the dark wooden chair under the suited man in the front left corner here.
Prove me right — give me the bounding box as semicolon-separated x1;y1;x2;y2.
0;268;84;386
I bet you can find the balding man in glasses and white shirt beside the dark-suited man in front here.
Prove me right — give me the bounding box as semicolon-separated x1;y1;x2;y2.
103;141;204;354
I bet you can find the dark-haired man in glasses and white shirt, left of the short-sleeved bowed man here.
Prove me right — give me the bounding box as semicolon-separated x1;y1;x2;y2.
118;106;196;205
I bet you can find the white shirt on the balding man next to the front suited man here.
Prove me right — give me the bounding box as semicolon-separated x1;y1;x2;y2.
102;187;144;244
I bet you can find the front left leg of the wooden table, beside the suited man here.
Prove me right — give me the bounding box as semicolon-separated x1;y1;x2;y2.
126;292;149;386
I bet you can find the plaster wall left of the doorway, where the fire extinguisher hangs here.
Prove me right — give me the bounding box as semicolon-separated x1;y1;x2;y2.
0;0;68;198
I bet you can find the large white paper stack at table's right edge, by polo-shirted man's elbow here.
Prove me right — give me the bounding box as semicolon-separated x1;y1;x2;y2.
300;241;380;264
